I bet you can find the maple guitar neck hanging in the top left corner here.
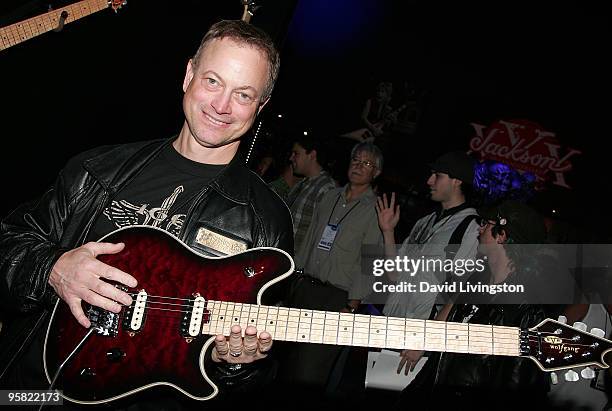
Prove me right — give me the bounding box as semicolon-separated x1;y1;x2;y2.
0;0;108;50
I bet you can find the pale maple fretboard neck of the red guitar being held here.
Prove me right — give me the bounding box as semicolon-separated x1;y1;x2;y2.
202;301;521;356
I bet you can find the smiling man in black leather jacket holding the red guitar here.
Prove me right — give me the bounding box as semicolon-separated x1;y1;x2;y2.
0;21;293;406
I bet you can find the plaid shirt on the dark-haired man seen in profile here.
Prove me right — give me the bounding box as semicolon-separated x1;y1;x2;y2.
287;171;337;250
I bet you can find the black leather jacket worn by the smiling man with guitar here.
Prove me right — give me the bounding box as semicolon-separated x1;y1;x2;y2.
0;139;293;392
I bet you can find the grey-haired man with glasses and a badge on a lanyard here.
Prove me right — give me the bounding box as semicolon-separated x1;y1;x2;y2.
282;143;383;396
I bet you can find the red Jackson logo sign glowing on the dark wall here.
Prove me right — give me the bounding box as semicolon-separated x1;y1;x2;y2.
470;119;582;188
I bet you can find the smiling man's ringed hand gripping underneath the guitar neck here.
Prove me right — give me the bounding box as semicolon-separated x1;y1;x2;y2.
211;325;272;364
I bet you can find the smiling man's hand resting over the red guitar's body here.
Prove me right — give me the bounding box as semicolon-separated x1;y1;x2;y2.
49;242;138;328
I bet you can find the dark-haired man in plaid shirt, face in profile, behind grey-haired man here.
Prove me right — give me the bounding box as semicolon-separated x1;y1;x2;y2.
287;136;336;252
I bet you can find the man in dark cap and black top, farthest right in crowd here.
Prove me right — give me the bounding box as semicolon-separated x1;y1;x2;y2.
395;200;549;410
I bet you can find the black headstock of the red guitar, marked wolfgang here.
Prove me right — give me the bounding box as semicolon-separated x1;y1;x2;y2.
521;319;612;371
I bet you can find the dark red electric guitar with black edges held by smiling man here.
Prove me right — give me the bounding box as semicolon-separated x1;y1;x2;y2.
43;226;612;404
